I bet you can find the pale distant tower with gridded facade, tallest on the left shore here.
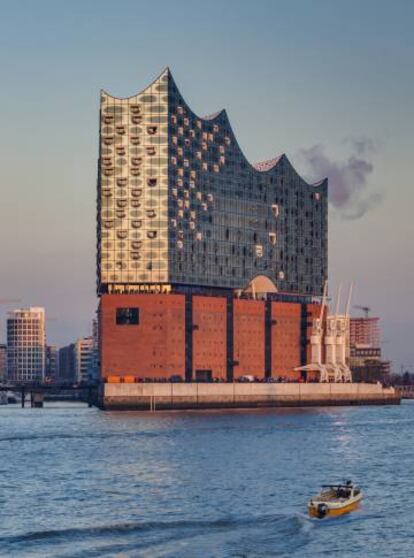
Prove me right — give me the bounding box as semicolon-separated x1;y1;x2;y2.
7;307;46;382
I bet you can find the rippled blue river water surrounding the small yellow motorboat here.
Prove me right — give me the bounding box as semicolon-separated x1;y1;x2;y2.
0;403;414;558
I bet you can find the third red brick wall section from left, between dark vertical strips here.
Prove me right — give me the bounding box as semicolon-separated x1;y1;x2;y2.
233;299;265;378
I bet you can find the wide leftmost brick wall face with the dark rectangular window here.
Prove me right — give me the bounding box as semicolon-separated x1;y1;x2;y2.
99;294;185;378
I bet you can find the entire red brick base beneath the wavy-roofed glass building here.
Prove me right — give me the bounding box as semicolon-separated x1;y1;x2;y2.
99;293;320;381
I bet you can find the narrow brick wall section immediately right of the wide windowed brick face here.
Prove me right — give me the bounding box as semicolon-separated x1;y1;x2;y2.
193;296;227;379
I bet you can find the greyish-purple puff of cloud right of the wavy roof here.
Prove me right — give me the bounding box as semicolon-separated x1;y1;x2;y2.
299;138;382;219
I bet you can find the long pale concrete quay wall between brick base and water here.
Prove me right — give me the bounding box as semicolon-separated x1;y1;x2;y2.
99;383;400;411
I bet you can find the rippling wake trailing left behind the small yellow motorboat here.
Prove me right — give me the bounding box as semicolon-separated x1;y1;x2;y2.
0;514;313;558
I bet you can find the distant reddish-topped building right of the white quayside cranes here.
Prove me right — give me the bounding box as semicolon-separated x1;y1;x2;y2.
349;317;391;382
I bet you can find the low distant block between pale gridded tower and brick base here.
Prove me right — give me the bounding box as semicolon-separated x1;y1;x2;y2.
59;337;96;382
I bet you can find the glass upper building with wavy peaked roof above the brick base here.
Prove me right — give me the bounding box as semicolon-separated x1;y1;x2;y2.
97;69;327;296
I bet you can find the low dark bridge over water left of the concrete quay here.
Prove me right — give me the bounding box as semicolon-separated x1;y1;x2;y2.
0;382;98;407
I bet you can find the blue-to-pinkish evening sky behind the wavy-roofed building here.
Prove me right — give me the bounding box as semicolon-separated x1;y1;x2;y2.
0;0;414;372
